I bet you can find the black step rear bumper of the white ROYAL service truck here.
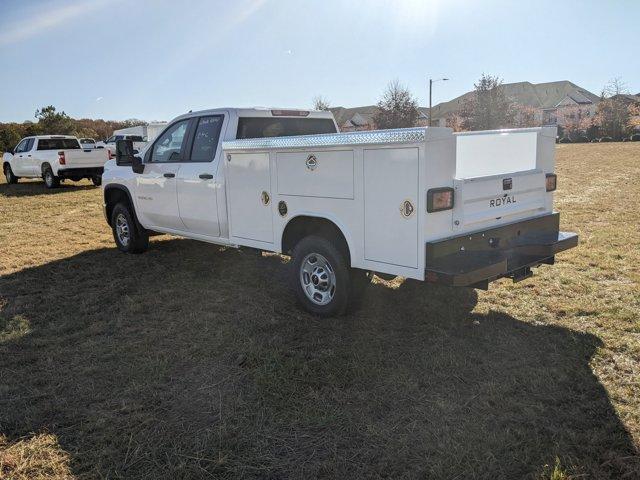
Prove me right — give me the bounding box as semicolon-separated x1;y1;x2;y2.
425;213;578;288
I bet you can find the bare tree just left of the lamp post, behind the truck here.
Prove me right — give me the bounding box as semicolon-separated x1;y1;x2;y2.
373;80;420;129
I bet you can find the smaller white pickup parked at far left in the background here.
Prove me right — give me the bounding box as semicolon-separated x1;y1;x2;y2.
2;135;109;188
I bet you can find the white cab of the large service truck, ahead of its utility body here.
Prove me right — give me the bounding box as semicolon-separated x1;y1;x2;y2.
103;108;338;238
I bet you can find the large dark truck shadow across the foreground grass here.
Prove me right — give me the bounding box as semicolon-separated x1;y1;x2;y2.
0;240;638;479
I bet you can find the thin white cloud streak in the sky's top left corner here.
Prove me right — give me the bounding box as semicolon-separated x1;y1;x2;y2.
0;0;120;46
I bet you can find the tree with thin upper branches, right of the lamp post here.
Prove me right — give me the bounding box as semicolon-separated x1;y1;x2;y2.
461;73;515;130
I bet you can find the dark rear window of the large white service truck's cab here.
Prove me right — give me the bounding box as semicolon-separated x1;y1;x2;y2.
236;117;336;139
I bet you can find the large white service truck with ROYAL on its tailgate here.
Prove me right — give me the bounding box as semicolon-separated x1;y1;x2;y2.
103;109;578;315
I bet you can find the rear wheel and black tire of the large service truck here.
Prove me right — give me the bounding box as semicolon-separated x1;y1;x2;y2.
291;236;355;317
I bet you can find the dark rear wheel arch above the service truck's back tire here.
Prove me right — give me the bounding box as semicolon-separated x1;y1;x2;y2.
281;215;352;265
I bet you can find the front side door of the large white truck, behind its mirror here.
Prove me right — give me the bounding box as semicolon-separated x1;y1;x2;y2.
135;120;189;231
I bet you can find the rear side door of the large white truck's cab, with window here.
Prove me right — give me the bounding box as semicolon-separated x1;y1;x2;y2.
177;115;224;237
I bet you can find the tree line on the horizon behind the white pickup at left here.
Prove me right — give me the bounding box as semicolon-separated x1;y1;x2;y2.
0;105;147;152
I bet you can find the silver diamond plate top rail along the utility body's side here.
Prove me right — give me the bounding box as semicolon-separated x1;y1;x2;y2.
222;127;427;151
